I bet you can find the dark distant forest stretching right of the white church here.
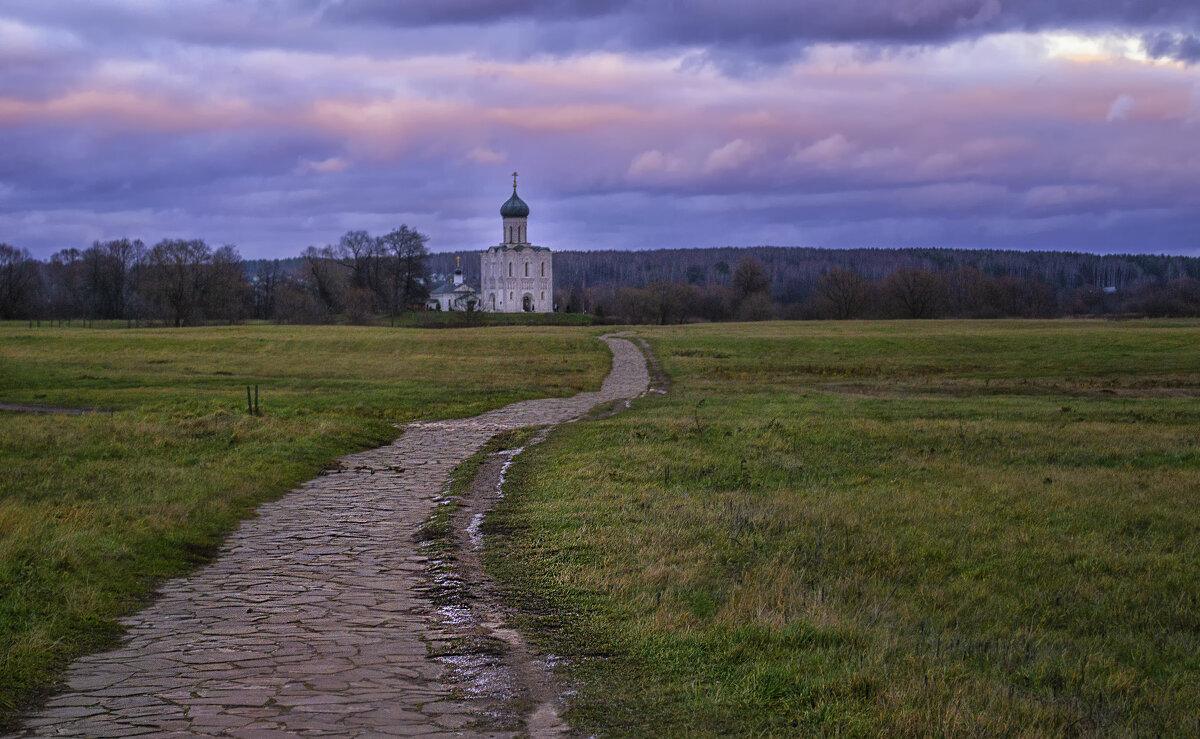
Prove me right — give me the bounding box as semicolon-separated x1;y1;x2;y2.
431;247;1200;323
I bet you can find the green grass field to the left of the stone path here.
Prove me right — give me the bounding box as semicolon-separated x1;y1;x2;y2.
0;324;610;726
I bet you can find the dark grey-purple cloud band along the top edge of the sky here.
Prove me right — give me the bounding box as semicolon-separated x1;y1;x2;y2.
11;0;1200;61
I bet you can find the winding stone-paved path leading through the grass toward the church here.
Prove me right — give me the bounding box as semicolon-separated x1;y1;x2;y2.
16;337;648;738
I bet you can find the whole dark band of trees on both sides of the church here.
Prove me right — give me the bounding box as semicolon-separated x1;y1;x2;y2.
0;238;1200;325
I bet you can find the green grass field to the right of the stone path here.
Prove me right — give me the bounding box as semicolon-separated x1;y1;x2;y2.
486;320;1200;735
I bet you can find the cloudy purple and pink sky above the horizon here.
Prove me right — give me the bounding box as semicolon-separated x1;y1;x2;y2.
0;0;1200;258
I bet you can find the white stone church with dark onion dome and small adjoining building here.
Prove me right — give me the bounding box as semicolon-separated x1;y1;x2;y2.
426;172;554;313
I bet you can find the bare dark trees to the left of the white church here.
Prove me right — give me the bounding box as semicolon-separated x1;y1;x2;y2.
0;226;428;326
